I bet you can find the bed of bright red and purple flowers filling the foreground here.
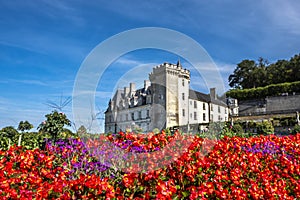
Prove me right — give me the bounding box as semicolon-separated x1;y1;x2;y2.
0;132;300;199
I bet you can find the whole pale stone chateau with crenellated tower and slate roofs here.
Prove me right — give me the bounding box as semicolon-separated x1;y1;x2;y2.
105;61;229;132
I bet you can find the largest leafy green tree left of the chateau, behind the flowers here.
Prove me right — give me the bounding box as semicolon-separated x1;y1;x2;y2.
38;110;71;141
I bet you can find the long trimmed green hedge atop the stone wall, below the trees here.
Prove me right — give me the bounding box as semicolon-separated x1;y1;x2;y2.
226;81;300;100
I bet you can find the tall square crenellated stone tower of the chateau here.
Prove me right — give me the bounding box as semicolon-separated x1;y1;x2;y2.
149;61;190;128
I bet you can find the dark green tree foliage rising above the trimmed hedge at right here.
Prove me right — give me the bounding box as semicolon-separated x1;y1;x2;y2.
228;54;300;89
